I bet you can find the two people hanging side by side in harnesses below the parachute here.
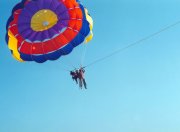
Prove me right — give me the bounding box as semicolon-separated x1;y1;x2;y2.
70;67;87;89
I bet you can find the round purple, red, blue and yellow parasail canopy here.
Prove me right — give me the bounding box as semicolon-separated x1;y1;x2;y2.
6;0;93;63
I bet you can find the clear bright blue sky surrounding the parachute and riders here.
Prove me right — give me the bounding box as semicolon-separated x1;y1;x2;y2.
0;0;180;132
